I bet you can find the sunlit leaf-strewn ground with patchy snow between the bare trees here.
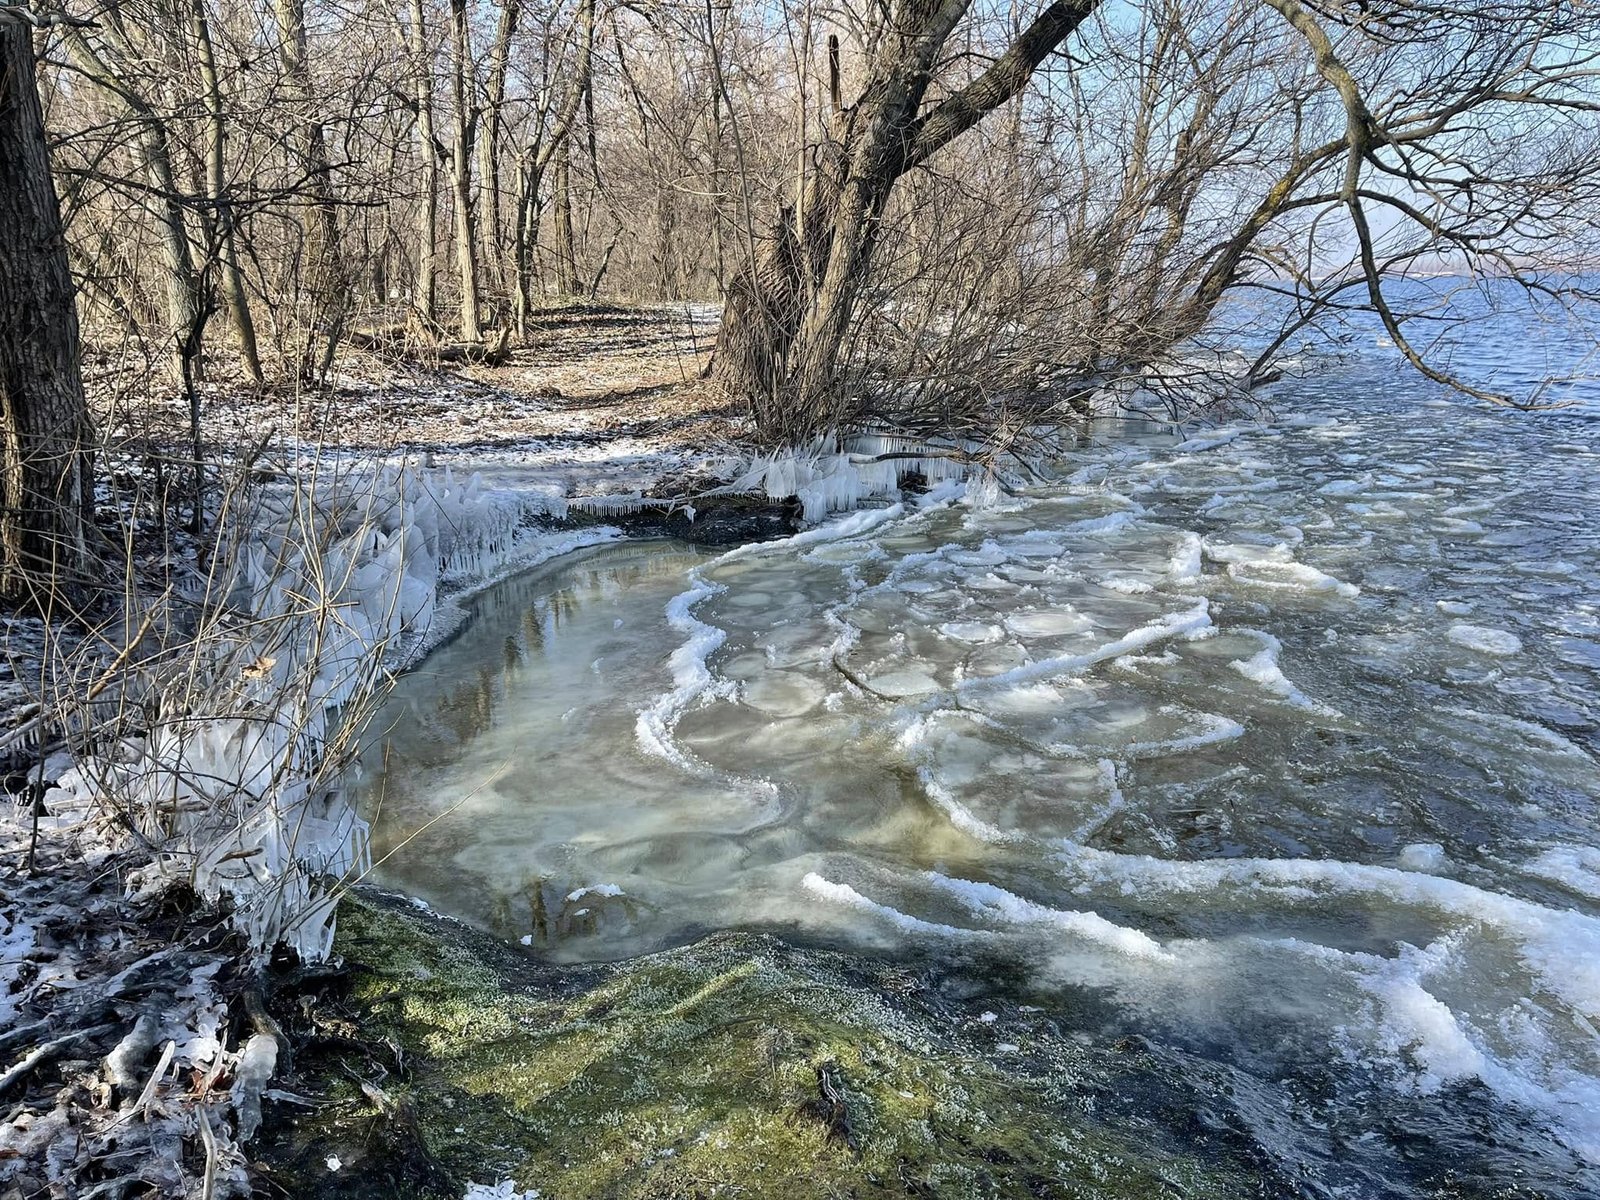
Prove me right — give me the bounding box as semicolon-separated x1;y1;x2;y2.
96;304;750;494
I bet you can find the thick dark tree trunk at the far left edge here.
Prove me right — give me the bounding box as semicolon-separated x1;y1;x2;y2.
0;18;94;608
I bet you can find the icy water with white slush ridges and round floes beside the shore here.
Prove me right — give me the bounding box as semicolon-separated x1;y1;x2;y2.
363;360;1600;1197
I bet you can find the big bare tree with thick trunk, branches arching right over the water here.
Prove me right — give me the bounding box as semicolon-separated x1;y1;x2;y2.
704;0;1597;440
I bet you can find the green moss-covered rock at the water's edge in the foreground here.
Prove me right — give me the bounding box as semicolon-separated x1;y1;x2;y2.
266;898;1267;1200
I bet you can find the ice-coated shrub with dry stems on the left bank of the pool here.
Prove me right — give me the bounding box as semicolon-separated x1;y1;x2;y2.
56;454;565;960
